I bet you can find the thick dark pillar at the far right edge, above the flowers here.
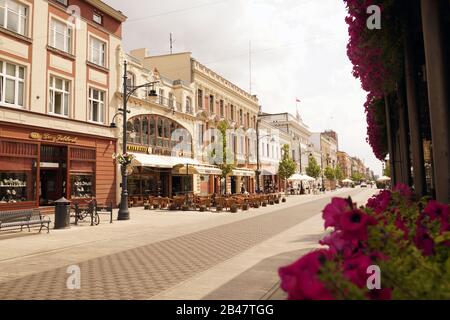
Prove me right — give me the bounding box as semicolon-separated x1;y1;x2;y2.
421;0;450;203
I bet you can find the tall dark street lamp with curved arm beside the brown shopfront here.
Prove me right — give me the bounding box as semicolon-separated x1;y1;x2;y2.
111;61;159;220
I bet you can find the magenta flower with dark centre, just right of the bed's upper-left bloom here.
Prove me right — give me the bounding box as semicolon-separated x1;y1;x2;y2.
339;209;376;240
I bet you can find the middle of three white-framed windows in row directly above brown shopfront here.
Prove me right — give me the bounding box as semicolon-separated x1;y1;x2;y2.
49;76;70;117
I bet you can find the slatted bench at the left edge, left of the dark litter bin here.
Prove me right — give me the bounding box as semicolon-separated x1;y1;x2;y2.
0;209;51;233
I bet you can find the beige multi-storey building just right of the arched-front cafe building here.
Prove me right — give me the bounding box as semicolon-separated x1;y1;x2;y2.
141;50;259;193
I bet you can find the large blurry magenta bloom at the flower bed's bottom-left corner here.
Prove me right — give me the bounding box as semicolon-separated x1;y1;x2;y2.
278;249;333;300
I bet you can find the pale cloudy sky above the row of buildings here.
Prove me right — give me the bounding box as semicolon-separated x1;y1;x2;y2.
105;0;381;175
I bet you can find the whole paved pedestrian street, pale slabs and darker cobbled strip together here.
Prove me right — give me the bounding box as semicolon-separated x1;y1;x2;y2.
0;188;376;300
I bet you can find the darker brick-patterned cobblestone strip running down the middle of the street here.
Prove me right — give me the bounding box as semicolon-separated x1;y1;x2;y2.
0;190;370;300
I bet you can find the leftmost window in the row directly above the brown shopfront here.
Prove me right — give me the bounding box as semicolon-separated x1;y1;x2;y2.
0;61;25;107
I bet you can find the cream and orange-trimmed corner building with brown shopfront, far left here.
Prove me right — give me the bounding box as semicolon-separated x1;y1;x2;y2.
0;0;126;210
